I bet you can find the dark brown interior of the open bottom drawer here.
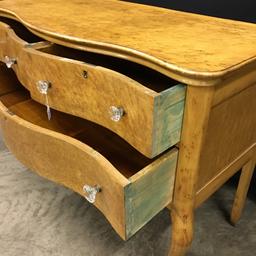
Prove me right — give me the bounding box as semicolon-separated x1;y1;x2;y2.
0;90;154;178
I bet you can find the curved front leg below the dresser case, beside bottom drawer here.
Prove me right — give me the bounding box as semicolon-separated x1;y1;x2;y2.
169;209;194;256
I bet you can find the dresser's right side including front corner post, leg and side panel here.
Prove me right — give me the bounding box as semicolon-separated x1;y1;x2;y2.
166;60;256;256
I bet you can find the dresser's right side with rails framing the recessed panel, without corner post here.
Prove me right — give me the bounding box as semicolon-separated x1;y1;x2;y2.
193;68;256;206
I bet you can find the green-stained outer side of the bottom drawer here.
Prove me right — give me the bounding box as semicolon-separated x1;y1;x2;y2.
125;149;178;237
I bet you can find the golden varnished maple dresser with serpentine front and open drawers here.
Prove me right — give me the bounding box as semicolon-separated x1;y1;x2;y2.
0;0;256;256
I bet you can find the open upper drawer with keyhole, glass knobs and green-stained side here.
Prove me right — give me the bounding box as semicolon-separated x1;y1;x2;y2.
0;18;185;158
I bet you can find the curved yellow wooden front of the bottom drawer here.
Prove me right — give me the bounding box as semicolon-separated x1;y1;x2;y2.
0;103;128;236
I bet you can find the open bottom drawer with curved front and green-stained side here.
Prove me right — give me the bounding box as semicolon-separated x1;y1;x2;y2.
0;65;178;239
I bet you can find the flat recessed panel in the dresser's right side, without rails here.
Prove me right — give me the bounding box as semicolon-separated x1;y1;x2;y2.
197;84;256;190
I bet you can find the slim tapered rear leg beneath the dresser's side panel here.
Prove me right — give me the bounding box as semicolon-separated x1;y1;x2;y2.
230;161;255;225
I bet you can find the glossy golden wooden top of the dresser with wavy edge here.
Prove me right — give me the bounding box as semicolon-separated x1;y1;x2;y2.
0;0;256;84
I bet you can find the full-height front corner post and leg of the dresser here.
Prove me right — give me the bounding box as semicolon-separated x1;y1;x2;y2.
169;86;213;256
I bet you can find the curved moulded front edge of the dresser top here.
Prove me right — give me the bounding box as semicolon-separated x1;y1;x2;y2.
0;0;256;86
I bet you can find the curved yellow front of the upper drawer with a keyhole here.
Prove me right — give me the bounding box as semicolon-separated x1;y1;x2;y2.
17;49;154;156
